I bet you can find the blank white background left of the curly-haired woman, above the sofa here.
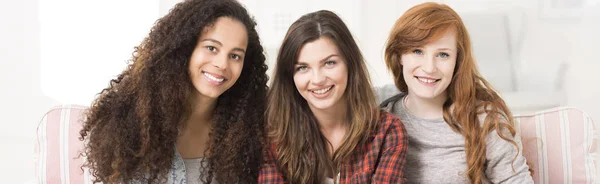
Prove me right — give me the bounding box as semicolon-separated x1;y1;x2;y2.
0;0;159;183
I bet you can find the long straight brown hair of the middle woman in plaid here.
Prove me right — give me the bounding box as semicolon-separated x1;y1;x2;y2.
267;10;379;183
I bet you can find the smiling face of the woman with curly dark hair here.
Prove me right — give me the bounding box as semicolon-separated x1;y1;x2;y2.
189;17;248;99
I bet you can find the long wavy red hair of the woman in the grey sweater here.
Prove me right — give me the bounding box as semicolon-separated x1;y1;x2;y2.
385;3;518;183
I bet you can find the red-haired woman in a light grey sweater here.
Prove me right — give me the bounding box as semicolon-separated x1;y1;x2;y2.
382;3;533;183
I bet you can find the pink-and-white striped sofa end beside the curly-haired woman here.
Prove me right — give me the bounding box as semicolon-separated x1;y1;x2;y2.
36;105;91;184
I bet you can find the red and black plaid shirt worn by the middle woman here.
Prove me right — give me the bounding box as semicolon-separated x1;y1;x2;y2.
258;112;408;184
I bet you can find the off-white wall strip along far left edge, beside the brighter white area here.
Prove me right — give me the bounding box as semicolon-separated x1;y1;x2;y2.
0;0;57;183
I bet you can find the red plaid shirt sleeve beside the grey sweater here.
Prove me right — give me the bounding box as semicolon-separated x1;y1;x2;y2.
372;114;408;183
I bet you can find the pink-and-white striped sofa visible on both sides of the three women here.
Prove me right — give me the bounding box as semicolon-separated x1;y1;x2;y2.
35;105;597;184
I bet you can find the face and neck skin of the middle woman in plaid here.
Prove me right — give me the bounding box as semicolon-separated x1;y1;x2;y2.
294;37;348;153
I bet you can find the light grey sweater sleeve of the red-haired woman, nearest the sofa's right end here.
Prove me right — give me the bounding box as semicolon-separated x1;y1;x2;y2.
485;127;533;183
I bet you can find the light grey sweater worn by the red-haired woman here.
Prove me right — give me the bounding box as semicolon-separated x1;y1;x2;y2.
379;87;533;184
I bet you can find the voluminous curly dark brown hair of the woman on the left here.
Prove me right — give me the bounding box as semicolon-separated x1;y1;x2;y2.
80;0;268;183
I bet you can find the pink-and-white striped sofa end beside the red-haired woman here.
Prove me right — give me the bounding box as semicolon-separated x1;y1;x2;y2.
515;107;597;184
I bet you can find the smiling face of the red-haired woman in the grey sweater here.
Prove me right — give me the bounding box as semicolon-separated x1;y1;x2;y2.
401;30;457;102
